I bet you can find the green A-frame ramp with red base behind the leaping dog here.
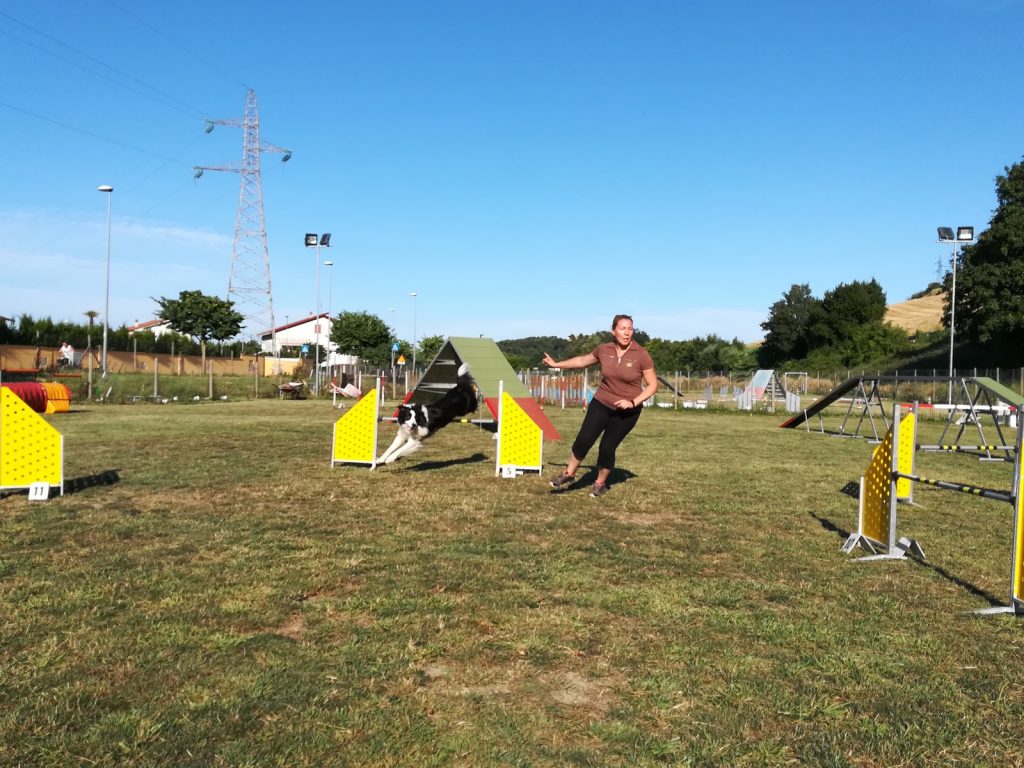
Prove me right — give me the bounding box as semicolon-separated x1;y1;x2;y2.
406;336;562;440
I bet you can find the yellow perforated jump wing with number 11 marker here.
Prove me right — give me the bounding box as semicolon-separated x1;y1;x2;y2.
0;387;63;501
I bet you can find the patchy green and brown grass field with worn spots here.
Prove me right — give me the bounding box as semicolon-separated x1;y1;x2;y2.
0;400;1024;766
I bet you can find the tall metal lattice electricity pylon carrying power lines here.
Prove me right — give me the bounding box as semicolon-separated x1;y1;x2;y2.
194;88;292;355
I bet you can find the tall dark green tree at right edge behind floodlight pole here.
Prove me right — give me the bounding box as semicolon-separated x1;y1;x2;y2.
944;156;1024;365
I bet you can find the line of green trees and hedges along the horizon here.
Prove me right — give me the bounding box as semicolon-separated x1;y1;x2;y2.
8;154;1024;371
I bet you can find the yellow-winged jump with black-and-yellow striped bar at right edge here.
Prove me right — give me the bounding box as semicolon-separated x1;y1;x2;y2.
843;403;1024;615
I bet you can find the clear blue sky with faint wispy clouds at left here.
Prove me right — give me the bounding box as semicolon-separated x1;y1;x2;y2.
0;0;1024;341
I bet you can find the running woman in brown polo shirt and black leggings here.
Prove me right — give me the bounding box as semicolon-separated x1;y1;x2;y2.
544;314;657;498
